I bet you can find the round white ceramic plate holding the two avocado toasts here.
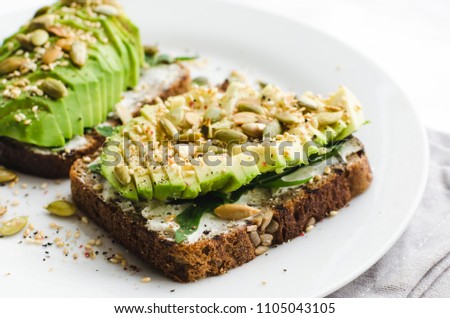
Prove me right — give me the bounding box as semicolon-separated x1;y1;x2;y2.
0;0;428;297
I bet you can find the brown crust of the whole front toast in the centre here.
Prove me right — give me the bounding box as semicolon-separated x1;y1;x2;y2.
70;145;372;282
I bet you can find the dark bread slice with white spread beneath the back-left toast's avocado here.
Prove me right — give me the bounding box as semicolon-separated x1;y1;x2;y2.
0;64;190;179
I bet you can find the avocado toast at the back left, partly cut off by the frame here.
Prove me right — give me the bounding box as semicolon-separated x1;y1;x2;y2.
0;0;189;178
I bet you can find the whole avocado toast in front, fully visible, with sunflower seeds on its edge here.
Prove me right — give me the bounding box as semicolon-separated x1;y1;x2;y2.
70;80;372;282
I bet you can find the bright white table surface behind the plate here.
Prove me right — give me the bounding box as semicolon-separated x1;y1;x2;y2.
5;0;450;133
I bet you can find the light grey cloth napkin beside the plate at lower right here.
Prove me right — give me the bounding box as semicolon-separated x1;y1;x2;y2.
329;131;450;297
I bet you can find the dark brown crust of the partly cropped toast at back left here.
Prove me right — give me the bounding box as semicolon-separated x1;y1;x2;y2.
0;66;191;179
